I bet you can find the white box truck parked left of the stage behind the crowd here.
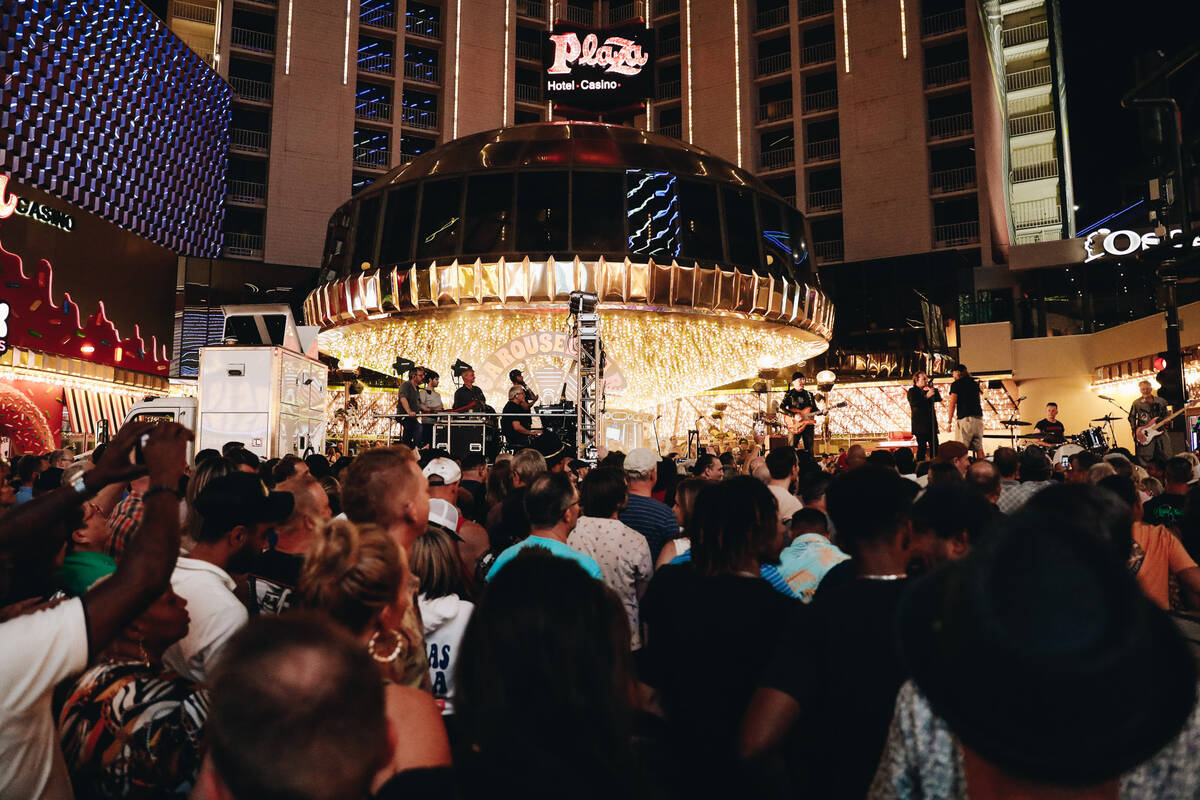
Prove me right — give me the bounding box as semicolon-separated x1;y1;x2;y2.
125;305;328;458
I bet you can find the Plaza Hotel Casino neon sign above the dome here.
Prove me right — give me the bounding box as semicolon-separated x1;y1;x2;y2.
541;25;654;110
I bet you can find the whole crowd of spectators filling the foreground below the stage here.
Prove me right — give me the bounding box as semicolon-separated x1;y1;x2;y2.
0;423;1200;800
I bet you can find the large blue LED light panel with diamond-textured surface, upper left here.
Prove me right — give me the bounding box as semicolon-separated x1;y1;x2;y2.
0;0;233;258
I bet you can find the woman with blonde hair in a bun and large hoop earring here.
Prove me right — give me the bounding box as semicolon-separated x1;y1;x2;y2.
298;519;450;790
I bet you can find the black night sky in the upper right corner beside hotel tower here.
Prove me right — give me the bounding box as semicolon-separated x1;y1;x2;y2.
1061;0;1200;229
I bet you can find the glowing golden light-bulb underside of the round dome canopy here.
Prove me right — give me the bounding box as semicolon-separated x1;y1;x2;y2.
320;308;827;409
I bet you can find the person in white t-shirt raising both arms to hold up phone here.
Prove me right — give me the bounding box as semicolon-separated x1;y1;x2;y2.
0;423;192;800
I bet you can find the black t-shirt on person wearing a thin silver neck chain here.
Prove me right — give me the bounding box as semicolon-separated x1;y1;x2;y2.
762;578;908;799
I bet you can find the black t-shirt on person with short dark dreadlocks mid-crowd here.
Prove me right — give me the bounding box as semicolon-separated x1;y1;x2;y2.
638;564;799;759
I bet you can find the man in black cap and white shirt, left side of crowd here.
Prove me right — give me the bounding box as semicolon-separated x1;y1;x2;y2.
162;473;294;684
